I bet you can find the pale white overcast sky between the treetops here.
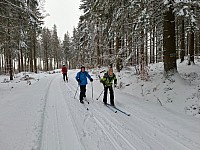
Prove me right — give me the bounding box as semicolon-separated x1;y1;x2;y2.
44;0;81;40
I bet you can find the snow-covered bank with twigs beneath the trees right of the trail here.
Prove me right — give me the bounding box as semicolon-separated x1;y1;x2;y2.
111;60;200;118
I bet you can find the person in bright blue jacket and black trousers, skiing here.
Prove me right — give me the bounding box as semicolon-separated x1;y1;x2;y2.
76;66;93;103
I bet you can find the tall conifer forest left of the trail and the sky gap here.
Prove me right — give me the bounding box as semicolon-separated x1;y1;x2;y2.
0;0;67;80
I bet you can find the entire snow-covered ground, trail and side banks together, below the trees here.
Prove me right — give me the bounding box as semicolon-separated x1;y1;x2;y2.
0;63;200;150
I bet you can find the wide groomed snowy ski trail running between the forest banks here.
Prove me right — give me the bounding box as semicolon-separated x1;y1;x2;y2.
0;71;200;150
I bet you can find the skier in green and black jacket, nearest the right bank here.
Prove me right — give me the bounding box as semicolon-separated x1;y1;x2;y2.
100;68;117;106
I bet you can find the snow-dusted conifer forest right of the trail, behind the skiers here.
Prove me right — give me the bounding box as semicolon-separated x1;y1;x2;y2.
69;0;200;79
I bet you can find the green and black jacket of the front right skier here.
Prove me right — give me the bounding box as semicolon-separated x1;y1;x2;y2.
100;73;117;86
